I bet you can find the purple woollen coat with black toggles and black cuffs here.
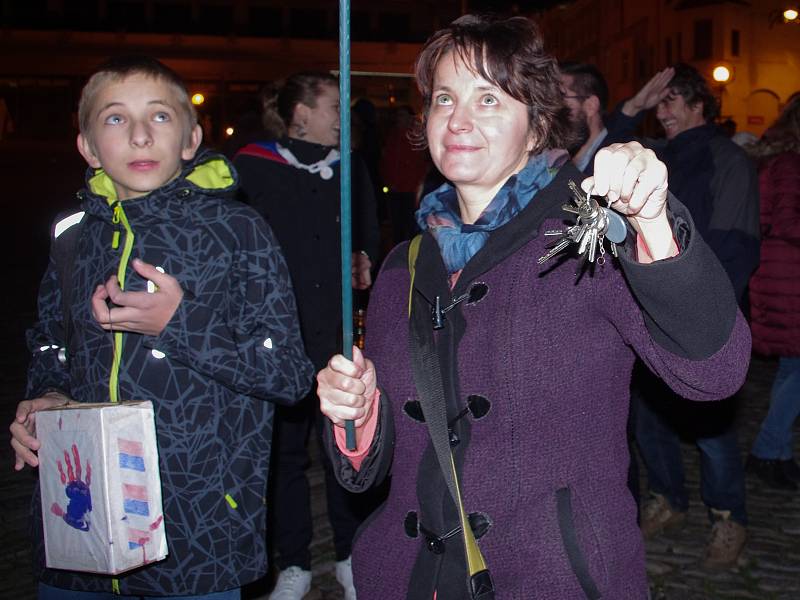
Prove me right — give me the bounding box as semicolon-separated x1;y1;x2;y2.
332;165;750;600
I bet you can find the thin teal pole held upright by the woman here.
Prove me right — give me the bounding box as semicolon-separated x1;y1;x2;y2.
339;0;356;450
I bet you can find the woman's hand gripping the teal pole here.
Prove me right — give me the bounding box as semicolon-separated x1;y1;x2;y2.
317;346;377;428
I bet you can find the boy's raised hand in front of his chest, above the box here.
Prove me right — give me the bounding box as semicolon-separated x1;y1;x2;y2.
92;258;183;335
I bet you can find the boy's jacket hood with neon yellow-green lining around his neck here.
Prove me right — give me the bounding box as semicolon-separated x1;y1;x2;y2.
78;149;239;220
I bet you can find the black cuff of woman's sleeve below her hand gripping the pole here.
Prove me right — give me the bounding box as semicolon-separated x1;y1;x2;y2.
324;390;394;492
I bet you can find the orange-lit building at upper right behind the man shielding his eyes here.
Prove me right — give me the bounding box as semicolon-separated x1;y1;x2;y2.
535;0;800;135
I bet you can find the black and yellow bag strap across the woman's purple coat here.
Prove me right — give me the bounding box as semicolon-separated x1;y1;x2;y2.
408;242;494;600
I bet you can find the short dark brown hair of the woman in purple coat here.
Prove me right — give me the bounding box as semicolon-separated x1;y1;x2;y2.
414;15;571;154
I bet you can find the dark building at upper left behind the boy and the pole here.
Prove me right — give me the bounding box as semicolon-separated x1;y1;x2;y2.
0;0;463;142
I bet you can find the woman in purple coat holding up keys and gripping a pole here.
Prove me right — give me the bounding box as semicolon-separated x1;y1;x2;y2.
318;16;750;600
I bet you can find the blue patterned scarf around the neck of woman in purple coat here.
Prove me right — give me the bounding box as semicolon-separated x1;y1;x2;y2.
417;150;569;274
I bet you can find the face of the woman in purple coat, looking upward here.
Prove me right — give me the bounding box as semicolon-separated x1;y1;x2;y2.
427;52;534;200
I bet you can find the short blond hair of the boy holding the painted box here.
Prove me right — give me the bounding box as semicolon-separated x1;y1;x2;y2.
78;56;197;139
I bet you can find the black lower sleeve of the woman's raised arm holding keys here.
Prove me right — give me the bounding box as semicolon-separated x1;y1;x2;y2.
620;194;738;360
